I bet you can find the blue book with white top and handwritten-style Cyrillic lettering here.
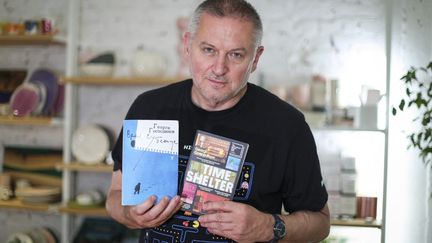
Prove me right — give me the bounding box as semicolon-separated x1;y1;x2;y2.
122;120;179;205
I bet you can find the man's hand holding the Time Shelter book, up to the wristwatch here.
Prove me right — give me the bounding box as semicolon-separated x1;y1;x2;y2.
198;201;274;242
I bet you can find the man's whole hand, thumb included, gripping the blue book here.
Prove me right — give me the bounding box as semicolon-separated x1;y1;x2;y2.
105;170;181;228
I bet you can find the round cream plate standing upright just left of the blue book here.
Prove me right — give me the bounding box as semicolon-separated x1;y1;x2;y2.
72;125;110;164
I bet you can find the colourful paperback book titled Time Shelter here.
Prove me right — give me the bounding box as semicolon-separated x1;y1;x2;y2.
181;130;249;214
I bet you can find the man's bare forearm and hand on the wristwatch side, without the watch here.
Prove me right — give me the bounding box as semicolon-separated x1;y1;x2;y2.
199;201;330;242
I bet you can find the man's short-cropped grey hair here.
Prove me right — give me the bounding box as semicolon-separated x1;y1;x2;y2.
188;0;263;47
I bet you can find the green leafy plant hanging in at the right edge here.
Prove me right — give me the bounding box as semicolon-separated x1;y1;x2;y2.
392;62;432;164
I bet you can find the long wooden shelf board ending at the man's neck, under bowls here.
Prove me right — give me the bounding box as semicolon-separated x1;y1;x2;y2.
61;77;185;85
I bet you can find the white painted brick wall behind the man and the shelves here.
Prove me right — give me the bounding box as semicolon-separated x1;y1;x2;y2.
0;0;431;242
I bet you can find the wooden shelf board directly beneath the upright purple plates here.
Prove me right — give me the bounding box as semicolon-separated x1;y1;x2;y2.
0;115;63;126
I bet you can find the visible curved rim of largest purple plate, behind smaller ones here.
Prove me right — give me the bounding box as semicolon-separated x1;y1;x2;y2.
29;69;58;115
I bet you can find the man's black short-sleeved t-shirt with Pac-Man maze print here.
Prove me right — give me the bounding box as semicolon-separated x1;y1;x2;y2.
112;80;327;242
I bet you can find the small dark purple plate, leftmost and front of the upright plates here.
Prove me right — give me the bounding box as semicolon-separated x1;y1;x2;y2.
10;83;40;116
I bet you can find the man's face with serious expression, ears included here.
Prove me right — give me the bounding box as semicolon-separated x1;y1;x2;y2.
184;13;264;110
